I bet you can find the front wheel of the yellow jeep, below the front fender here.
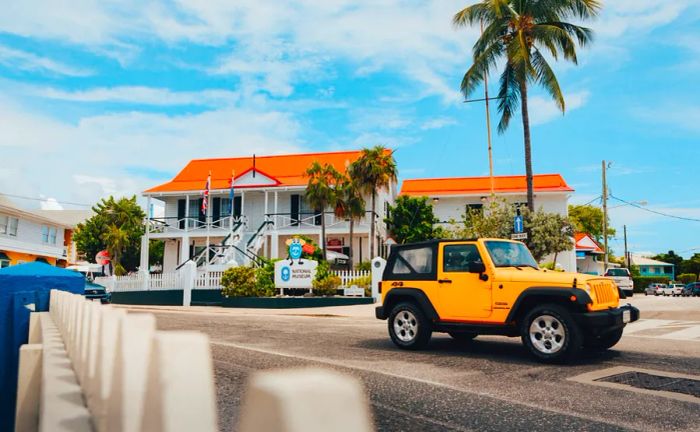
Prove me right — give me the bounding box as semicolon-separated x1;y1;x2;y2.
520;304;583;363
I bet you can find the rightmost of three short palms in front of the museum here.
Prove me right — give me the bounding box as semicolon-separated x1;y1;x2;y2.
349;146;398;258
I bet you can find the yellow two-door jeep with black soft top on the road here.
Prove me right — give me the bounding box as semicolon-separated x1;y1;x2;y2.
376;239;639;362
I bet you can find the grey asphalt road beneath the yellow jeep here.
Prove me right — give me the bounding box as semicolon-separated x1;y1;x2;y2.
131;297;700;431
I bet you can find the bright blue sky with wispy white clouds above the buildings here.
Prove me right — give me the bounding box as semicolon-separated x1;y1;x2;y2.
0;0;700;256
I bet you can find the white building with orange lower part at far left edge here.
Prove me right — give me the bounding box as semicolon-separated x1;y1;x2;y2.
0;196;72;268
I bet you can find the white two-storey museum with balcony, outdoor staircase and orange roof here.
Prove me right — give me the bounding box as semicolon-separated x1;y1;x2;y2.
141;151;396;273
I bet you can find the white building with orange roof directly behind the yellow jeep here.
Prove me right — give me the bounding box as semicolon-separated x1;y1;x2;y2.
400;174;576;271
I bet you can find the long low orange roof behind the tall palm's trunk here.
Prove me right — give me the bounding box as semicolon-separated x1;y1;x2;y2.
401;174;573;196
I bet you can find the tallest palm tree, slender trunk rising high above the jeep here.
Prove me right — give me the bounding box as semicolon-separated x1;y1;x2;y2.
453;0;601;211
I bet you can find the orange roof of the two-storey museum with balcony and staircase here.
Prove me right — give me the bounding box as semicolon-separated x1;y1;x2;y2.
144;150;388;193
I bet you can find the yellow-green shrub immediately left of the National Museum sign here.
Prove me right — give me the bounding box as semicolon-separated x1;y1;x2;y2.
221;264;275;297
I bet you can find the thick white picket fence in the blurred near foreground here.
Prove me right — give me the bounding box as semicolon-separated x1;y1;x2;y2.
15;290;373;432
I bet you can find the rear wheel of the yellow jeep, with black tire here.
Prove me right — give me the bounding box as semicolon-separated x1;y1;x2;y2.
388;302;433;350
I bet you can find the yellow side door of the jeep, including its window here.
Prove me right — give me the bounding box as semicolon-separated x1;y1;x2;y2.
438;242;491;321
